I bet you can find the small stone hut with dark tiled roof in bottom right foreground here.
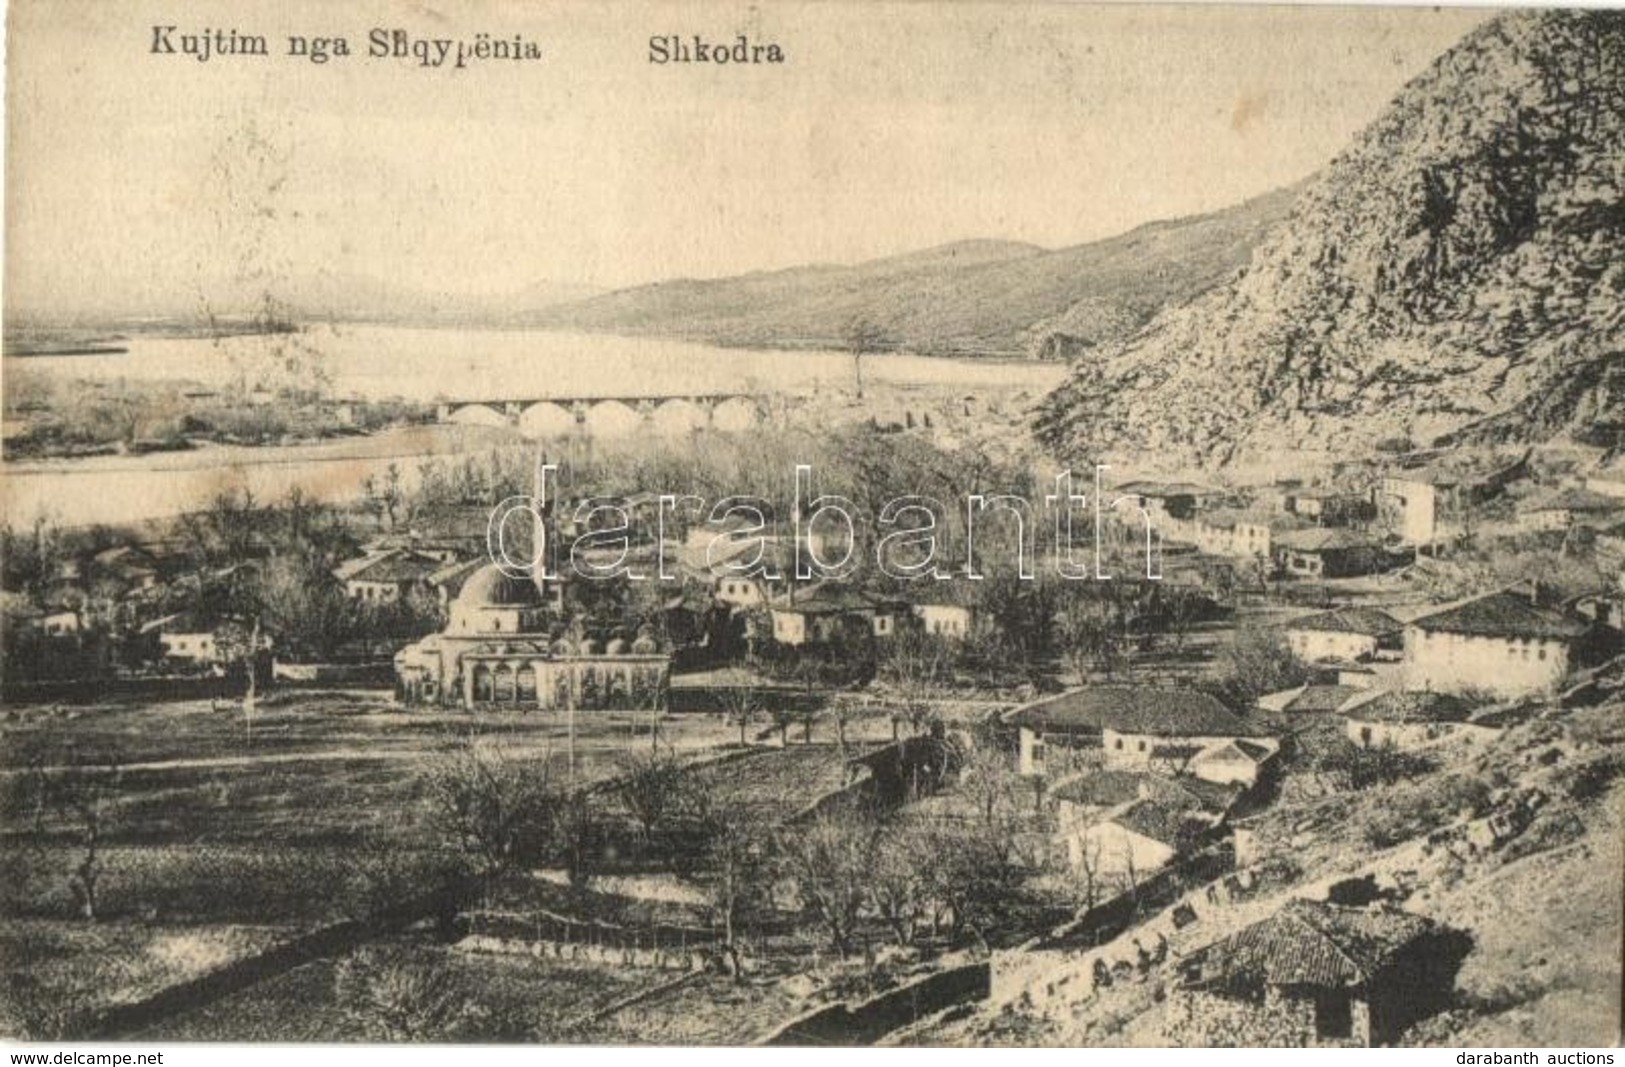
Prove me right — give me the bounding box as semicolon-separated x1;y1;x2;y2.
1164;900;1466;1048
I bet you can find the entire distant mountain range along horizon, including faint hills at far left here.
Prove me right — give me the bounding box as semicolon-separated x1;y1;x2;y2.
8;190;1294;359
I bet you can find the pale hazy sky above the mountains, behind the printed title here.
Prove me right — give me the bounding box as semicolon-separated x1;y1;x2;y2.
5;0;1487;313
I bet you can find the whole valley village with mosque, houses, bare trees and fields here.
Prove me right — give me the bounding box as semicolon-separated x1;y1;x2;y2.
5;412;1625;1044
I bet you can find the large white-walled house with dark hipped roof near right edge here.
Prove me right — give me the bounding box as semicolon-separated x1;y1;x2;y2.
1404;591;1589;697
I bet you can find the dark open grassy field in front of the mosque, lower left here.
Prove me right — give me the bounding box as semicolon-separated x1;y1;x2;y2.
0;692;889;1041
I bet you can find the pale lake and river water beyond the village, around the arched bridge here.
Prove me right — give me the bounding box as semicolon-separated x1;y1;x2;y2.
0;326;1066;526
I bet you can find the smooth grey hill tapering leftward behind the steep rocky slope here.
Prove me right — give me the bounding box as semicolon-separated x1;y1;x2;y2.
522;190;1292;359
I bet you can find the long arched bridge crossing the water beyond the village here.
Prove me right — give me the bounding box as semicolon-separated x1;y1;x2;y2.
437;393;770;440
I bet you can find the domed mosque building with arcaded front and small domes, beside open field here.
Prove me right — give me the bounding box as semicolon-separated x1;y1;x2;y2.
395;564;671;711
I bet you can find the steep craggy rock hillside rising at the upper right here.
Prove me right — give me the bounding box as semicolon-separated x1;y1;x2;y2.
1038;11;1625;466
